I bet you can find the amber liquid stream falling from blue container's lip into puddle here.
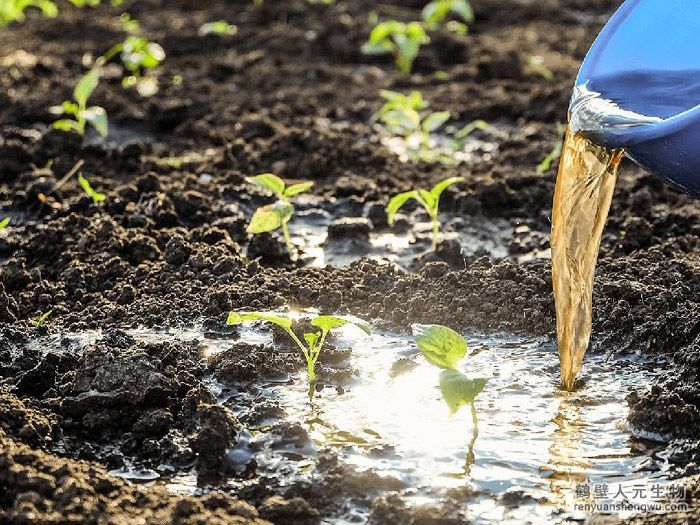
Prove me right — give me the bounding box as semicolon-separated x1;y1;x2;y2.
551;128;623;390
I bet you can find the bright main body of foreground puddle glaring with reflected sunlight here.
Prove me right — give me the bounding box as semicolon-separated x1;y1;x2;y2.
227;326;664;523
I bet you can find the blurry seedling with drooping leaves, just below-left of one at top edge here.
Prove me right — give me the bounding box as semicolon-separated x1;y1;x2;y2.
362;20;430;75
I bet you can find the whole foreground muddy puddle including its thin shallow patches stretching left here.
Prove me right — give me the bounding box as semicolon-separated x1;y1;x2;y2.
24;326;667;524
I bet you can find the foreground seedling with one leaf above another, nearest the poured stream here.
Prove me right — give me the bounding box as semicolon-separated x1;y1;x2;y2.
412;324;488;416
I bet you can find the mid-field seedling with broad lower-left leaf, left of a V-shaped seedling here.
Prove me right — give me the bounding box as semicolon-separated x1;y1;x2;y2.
247;173;314;253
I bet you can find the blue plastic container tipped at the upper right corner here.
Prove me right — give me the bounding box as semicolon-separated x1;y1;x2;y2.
570;0;700;197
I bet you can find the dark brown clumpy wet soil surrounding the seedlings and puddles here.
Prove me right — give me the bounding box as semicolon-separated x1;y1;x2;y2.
0;0;700;523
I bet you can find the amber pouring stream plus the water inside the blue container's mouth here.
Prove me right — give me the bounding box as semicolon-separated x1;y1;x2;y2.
551;70;700;390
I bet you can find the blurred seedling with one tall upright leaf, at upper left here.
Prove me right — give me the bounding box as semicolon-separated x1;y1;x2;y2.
50;68;109;137
